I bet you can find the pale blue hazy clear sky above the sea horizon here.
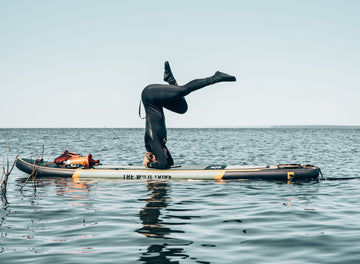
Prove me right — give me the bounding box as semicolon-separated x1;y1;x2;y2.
0;0;360;128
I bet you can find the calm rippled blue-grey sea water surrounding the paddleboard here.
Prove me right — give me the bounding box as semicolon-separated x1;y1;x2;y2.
0;128;360;264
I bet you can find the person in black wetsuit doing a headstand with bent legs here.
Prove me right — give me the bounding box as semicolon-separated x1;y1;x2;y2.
141;61;236;169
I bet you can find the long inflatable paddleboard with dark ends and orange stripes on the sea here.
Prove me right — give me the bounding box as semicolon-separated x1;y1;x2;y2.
16;158;320;181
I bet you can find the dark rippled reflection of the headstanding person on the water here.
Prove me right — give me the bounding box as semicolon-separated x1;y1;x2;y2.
136;181;192;264
